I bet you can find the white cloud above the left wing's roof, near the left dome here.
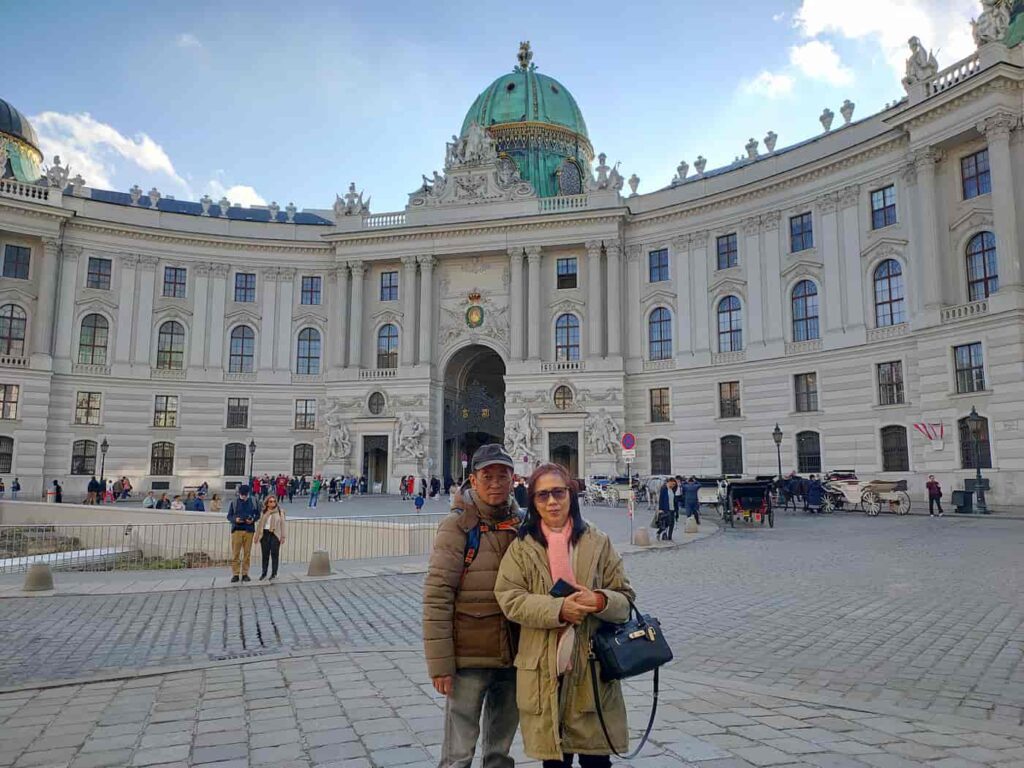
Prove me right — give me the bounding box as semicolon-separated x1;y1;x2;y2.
31;112;188;193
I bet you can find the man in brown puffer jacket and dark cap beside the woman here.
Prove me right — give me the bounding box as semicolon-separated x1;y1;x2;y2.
423;444;520;768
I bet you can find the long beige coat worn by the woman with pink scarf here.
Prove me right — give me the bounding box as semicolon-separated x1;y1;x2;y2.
495;524;634;760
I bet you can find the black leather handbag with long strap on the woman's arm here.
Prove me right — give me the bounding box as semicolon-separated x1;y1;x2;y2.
590;601;672;760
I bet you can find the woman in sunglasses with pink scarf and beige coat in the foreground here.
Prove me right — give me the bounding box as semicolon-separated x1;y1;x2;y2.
495;464;634;768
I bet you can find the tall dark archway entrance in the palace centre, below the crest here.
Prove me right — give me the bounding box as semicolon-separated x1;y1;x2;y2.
442;345;505;484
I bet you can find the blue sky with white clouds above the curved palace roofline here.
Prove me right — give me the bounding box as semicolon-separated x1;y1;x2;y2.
9;0;980;212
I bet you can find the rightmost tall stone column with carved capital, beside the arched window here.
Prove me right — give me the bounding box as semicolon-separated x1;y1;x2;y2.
978;113;1021;289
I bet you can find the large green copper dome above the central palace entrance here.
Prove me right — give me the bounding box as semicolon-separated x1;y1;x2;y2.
462;42;594;198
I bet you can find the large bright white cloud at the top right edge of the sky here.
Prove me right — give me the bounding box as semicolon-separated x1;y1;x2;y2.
795;0;981;76
